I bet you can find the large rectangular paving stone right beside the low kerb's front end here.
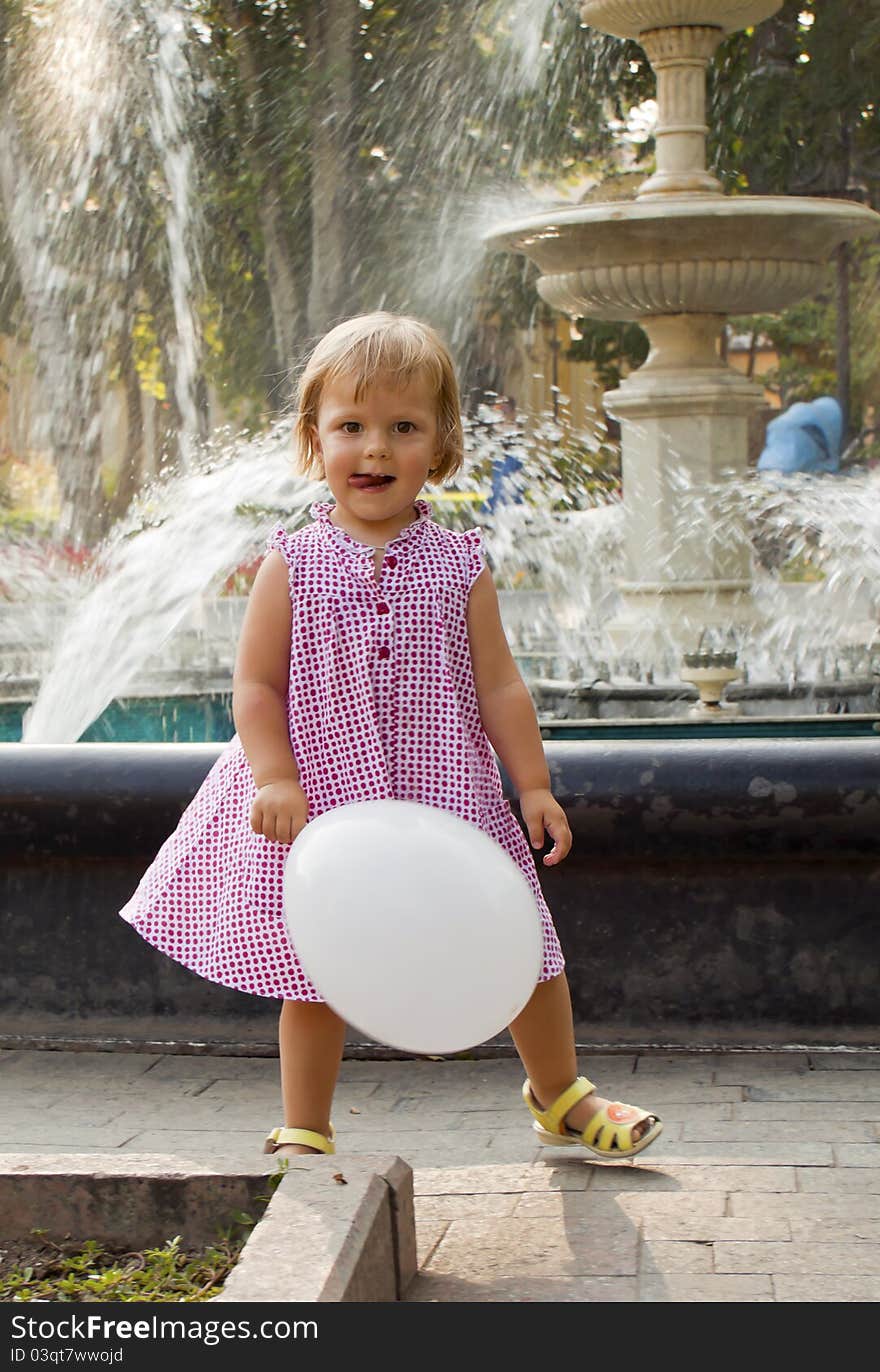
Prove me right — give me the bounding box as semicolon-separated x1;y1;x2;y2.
427;1216;638;1281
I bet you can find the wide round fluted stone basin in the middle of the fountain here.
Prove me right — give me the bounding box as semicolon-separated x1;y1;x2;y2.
486;195;880;320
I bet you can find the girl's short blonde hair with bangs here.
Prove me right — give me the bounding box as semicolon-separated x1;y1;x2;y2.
294;310;464;483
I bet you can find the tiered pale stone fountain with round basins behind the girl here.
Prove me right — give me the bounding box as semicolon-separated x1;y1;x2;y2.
489;0;880;668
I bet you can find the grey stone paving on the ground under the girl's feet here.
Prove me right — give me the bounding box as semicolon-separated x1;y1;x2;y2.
0;1050;880;1302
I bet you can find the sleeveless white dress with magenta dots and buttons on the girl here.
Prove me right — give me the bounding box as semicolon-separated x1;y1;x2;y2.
121;501;564;1002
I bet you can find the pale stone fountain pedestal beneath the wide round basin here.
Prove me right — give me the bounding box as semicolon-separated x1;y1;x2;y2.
605;314;763;670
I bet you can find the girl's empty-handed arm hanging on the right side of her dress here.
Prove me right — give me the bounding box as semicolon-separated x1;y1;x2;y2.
468;568;571;867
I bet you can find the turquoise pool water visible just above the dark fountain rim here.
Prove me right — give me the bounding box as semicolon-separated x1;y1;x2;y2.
0;691;880;744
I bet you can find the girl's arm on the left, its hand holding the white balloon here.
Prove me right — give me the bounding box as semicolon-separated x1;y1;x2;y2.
232;552;308;842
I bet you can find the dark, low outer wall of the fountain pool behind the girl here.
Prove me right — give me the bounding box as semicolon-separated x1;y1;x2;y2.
0;733;880;1044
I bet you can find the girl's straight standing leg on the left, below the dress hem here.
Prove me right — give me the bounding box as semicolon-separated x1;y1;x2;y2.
276;1000;346;1157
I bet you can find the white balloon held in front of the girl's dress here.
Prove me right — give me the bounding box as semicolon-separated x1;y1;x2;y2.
284;800;544;1054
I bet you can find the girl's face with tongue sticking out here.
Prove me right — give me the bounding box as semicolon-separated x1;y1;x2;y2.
312;376;439;542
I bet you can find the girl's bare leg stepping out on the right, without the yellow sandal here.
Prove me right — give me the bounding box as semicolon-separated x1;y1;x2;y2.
509;973;651;1140
